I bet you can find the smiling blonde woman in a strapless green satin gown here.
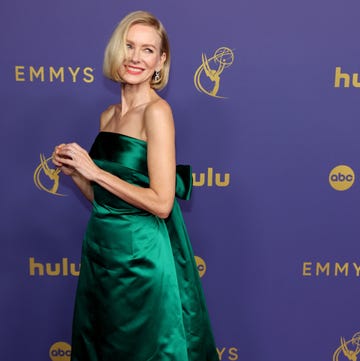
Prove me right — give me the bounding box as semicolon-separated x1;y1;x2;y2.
53;11;218;361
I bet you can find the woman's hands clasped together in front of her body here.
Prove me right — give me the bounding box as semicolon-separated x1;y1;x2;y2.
53;143;100;181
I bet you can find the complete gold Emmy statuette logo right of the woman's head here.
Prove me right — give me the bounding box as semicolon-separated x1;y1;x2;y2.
194;47;234;98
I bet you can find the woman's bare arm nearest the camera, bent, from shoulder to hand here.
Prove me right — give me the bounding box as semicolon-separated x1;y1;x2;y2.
54;100;176;218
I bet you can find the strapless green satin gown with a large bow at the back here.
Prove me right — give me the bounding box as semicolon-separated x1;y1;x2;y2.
71;132;219;361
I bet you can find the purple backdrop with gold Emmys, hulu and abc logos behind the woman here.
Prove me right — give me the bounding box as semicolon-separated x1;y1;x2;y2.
0;0;360;361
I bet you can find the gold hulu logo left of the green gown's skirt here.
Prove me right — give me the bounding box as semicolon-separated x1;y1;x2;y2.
29;257;80;277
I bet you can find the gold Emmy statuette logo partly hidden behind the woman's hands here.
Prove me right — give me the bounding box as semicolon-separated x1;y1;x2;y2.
34;154;65;196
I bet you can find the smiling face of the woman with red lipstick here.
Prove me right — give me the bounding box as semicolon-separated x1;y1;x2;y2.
119;24;166;85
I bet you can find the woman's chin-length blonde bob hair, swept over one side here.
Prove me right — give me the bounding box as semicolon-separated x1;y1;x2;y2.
103;11;170;90
